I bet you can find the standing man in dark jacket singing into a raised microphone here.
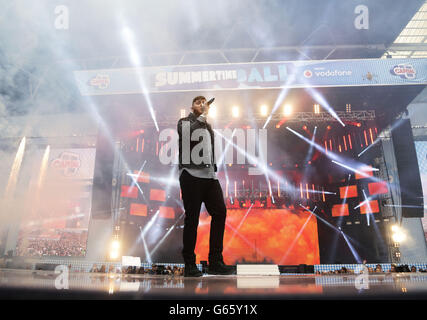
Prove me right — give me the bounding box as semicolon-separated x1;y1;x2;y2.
177;96;234;277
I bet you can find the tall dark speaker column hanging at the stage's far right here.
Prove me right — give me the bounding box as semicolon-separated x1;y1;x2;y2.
392;119;424;218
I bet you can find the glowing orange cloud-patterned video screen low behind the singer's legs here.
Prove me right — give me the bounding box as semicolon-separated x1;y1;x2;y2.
196;208;319;265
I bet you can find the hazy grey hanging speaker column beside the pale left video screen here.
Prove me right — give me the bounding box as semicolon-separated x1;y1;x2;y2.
92;130;114;219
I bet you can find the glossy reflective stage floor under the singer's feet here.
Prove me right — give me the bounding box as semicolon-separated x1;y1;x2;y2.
0;269;427;300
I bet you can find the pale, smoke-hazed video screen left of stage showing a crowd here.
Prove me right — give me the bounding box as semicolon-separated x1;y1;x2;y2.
16;148;95;257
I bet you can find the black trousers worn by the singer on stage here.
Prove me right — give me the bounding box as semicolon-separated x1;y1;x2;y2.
179;170;227;264
